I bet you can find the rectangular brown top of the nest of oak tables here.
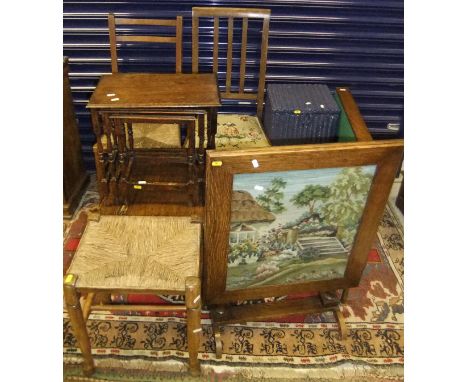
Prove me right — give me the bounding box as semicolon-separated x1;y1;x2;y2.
87;73;221;109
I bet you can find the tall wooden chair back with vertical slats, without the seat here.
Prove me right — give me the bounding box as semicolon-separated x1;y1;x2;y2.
192;7;271;118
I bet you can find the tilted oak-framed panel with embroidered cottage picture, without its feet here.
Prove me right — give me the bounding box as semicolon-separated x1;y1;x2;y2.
202;140;403;305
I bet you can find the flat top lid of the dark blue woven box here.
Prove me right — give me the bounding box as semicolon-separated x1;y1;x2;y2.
267;84;340;113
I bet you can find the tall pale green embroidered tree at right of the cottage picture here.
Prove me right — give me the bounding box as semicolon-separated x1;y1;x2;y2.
321;167;372;246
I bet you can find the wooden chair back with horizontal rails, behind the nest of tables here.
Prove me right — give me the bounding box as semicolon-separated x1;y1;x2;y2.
108;13;183;73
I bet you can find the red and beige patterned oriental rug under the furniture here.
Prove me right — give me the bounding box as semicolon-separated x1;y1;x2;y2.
63;181;404;382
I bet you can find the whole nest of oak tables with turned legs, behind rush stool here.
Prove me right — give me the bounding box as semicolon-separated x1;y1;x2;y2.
87;73;221;205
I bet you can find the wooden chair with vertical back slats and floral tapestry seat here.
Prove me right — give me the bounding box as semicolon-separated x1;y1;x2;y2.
192;7;271;150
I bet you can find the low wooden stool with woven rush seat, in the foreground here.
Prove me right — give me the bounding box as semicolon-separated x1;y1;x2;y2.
64;216;202;375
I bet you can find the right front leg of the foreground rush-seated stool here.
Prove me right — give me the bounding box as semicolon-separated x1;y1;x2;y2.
185;277;202;376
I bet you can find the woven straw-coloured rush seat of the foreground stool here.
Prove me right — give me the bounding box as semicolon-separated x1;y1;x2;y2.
68;216;201;291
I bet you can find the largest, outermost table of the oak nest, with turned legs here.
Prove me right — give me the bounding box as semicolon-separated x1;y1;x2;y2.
87;73;221;203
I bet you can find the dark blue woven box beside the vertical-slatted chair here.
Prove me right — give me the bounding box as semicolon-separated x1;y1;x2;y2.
263;84;341;145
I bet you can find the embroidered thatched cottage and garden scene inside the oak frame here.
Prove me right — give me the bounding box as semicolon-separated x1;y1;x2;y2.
227;166;375;289
